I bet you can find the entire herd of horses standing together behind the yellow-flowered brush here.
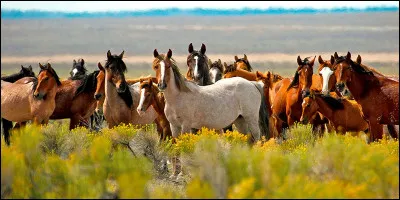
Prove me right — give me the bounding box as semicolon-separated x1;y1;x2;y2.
1;43;399;148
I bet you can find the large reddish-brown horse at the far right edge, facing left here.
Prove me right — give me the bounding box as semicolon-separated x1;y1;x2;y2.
333;52;399;141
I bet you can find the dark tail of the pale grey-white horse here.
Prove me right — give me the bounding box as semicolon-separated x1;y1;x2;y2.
253;82;271;140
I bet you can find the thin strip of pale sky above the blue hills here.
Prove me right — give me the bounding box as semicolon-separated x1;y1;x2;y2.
1;1;399;12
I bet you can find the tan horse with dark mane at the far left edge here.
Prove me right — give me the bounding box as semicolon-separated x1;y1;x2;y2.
1;63;61;145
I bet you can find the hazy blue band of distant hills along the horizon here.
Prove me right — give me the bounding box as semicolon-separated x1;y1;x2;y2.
1;6;399;19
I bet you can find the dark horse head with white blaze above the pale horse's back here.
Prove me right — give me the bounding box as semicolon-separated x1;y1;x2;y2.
186;43;212;85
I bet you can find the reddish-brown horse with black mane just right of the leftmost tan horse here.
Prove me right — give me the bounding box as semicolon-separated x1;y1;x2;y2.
50;68;103;130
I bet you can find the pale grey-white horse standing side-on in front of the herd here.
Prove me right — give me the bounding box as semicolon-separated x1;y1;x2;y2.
152;50;269;142
